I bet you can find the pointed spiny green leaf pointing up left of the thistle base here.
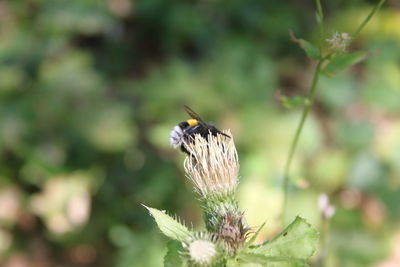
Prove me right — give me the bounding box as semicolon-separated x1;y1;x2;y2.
143;205;190;241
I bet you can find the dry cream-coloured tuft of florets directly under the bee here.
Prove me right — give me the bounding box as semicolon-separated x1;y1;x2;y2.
184;131;239;198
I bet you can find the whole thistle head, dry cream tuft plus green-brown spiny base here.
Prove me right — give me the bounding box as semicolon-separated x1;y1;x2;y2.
184;131;249;254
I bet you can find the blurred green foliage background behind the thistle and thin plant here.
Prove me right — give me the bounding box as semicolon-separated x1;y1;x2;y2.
0;0;400;267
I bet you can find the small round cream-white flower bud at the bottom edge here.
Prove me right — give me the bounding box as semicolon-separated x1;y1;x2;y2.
188;239;217;264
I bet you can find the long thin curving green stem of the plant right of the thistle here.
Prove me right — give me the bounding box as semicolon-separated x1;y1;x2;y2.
282;59;325;223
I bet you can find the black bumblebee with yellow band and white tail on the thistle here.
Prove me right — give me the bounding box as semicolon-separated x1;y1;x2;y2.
169;105;230;155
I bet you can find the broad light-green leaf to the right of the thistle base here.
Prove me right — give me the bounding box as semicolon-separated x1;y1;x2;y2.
247;217;318;260
